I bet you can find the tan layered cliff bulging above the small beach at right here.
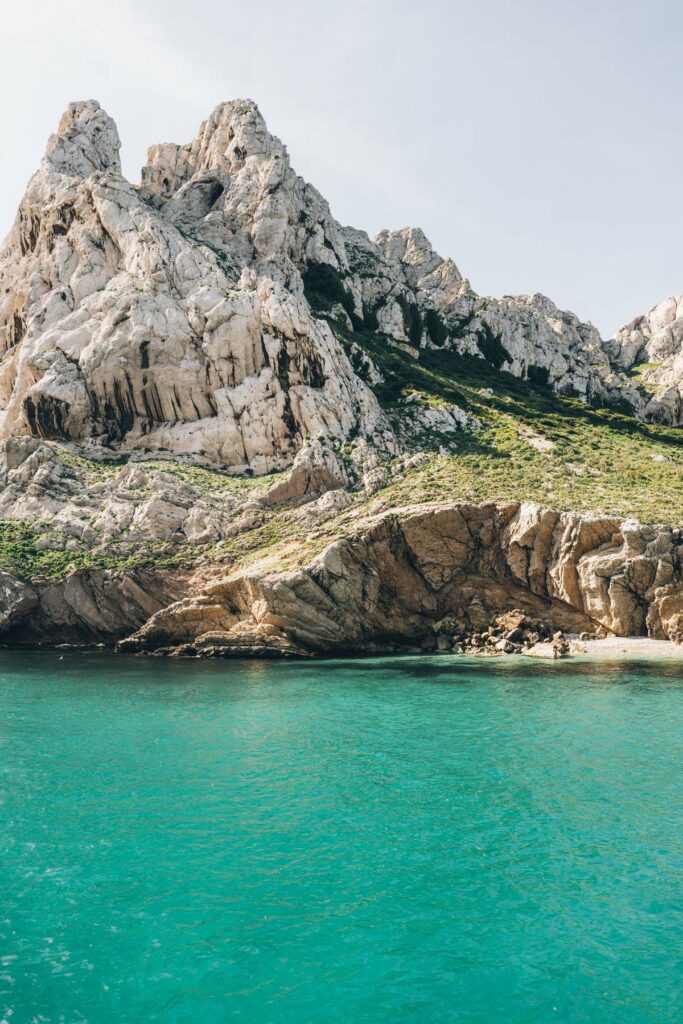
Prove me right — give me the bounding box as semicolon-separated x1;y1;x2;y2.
117;503;683;653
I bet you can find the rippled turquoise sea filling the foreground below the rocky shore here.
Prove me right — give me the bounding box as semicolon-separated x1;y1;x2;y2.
0;651;683;1024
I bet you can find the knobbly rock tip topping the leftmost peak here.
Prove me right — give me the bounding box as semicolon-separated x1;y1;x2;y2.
44;99;121;178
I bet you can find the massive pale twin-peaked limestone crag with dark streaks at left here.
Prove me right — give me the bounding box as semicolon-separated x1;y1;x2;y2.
0;101;388;472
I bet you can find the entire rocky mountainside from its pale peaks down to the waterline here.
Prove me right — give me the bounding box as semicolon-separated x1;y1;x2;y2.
0;100;683;655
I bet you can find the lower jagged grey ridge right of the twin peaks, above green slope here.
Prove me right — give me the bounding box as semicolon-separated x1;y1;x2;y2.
329;228;643;411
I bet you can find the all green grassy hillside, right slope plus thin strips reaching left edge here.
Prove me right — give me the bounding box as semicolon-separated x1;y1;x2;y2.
0;321;683;578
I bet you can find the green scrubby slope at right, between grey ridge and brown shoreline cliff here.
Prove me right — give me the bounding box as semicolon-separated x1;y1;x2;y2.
331;322;683;524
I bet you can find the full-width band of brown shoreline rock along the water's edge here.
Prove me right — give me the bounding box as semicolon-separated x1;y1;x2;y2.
0;502;683;657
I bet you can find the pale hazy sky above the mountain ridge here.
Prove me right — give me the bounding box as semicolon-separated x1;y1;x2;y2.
0;0;683;334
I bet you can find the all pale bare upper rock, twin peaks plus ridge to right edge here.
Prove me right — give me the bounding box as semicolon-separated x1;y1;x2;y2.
0;100;682;473
